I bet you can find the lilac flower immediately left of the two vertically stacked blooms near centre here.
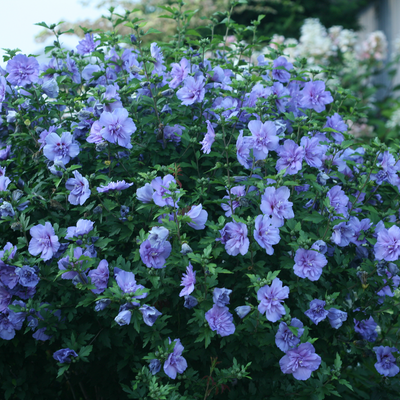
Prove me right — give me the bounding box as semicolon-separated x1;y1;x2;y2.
216;222;250;256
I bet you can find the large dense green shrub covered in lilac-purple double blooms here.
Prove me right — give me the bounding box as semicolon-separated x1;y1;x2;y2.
0;3;400;399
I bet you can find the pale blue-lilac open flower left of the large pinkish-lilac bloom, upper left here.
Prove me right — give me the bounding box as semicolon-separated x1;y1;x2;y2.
43;132;79;165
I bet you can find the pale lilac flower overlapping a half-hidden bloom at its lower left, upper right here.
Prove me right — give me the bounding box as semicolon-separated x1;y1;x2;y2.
248;120;279;160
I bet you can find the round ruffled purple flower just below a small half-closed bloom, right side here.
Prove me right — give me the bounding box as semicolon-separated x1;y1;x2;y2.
293;248;328;281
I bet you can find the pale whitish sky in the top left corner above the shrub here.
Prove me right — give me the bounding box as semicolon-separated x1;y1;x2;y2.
0;0;123;66
